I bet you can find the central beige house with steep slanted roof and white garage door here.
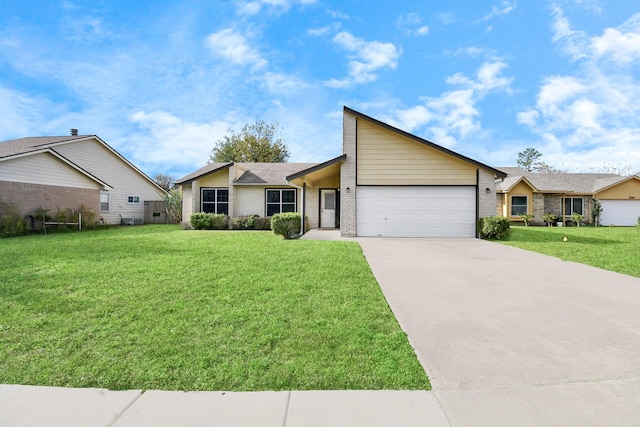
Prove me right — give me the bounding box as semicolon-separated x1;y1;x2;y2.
176;107;506;237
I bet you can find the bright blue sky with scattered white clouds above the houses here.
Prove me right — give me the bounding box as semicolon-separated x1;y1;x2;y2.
0;0;640;177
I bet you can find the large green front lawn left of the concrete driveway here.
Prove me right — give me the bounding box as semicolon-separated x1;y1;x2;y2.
0;226;430;391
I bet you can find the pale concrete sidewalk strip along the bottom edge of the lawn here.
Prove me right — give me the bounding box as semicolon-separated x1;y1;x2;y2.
0;385;450;427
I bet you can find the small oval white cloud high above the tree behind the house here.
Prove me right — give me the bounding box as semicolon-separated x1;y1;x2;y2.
205;28;267;67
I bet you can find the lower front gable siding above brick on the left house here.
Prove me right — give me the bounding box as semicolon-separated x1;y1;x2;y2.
0;153;100;189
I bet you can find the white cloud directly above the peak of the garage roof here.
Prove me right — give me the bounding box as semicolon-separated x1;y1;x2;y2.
326;31;400;88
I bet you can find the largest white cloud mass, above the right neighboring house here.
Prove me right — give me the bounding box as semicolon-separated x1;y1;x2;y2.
517;6;640;170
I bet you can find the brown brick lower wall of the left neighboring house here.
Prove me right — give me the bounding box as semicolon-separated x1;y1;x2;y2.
0;181;100;220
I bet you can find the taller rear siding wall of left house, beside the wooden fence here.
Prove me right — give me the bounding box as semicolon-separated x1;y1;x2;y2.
54;139;162;224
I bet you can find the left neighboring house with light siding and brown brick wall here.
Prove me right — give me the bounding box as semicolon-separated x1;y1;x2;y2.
0;130;165;224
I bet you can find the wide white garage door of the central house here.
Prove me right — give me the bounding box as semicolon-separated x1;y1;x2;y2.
356;187;476;237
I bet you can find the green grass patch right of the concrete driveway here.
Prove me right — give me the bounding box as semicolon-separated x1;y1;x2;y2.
500;227;640;277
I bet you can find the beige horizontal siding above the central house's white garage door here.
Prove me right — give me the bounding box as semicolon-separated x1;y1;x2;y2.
357;120;476;185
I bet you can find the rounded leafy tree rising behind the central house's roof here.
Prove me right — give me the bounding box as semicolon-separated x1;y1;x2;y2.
209;120;289;163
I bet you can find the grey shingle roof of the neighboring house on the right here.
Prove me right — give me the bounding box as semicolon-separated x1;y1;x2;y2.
496;167;633;194
